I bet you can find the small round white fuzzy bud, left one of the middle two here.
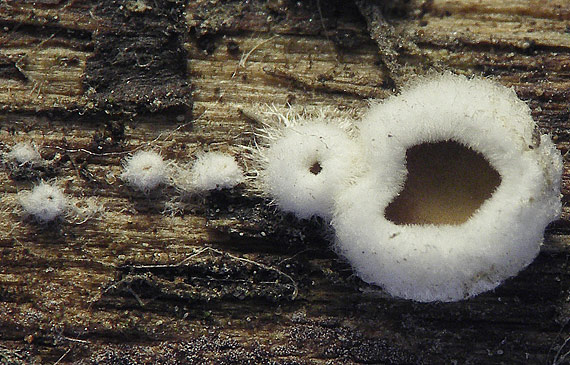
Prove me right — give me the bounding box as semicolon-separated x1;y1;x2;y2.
121;151;170;193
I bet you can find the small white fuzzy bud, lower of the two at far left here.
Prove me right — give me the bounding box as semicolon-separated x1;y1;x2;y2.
20;181;70;223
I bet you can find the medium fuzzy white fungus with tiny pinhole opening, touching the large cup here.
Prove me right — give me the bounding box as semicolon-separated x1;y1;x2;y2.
259;112;362;219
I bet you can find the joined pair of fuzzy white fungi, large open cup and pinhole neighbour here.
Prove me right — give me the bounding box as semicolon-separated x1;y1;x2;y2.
255;74;562;302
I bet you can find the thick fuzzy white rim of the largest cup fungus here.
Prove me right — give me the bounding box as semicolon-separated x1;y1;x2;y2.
333;74;562;302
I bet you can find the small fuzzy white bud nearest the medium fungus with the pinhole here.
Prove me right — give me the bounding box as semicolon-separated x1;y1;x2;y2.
188;152;244;191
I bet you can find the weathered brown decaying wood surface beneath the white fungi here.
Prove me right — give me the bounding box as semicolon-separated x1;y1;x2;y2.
0;0;570;364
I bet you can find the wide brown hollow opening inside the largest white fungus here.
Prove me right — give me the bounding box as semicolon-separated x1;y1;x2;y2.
384;140;501;225
